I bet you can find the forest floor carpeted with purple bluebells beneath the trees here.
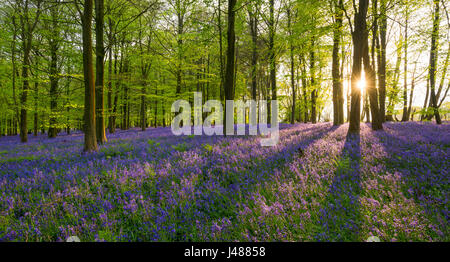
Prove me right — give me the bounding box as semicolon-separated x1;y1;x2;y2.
0;122;450;241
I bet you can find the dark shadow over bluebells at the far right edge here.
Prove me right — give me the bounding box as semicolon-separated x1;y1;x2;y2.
374;124;450;238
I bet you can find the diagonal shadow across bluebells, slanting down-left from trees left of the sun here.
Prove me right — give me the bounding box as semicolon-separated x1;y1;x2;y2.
164;126;337;241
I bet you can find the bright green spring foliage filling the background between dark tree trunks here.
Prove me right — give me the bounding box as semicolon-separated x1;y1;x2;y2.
0;0;449;133
